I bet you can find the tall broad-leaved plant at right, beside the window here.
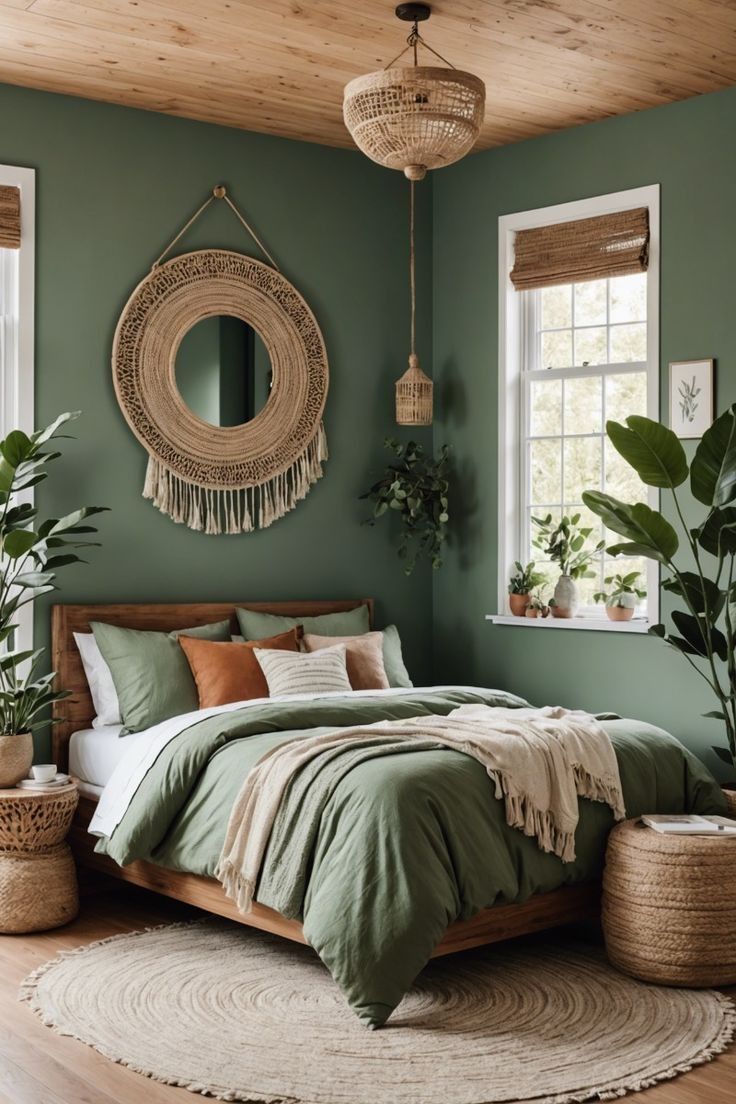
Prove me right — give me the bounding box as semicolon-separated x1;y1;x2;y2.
583;405;736;765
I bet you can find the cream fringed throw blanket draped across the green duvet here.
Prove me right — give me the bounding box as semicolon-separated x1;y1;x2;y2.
216;705;626;912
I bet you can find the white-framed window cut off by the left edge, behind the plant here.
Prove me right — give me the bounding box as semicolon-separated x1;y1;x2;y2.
0;164;35;648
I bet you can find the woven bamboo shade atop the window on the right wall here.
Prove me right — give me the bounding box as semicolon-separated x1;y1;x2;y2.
511;208;649;291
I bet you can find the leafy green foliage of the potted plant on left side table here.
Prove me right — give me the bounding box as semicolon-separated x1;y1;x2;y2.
0;413;106;736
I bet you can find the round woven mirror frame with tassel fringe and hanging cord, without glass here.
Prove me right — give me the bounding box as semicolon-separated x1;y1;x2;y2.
113;187;329;533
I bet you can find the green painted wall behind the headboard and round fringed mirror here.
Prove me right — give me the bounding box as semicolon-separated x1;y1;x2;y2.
0;86;431;751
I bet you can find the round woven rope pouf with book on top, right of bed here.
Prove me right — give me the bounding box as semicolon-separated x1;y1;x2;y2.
602;820;736;987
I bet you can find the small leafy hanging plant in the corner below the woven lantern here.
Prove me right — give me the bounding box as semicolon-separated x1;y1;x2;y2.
360;437;450;575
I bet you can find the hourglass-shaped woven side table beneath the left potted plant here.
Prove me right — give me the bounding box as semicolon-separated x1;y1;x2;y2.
0;783;79;933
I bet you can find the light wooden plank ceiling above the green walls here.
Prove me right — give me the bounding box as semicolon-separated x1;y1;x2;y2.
0;0;736;148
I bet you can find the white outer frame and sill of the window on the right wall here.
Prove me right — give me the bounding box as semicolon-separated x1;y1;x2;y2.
487;184;660;633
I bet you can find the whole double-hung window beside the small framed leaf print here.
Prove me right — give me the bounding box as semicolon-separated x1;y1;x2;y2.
498;187;659;630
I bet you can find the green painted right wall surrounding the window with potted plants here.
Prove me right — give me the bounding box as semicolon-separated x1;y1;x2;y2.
434;89;736;774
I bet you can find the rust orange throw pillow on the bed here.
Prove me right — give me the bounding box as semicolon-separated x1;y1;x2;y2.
179;626;301;709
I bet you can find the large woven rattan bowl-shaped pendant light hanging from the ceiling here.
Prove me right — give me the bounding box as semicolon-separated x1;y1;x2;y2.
342;3;486;180
